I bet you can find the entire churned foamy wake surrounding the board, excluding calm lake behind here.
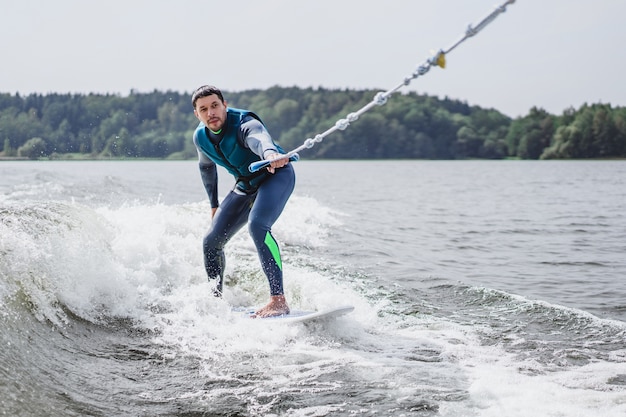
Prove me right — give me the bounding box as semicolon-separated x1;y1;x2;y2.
0;196;626;416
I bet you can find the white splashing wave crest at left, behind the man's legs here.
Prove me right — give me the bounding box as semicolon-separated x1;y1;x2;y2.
0;198;334;326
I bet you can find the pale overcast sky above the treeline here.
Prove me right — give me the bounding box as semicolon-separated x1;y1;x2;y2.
0;0;626;117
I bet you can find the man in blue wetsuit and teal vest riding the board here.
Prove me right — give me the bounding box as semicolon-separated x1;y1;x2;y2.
191;85;295;317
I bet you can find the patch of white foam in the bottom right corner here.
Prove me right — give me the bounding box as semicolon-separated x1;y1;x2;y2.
460;338;626;417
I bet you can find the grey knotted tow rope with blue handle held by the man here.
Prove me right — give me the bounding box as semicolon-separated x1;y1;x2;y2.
248;0;515;172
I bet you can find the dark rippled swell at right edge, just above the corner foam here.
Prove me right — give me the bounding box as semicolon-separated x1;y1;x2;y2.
448;286;626;372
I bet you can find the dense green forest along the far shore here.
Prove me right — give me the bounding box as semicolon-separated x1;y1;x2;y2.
0;86;626;159
